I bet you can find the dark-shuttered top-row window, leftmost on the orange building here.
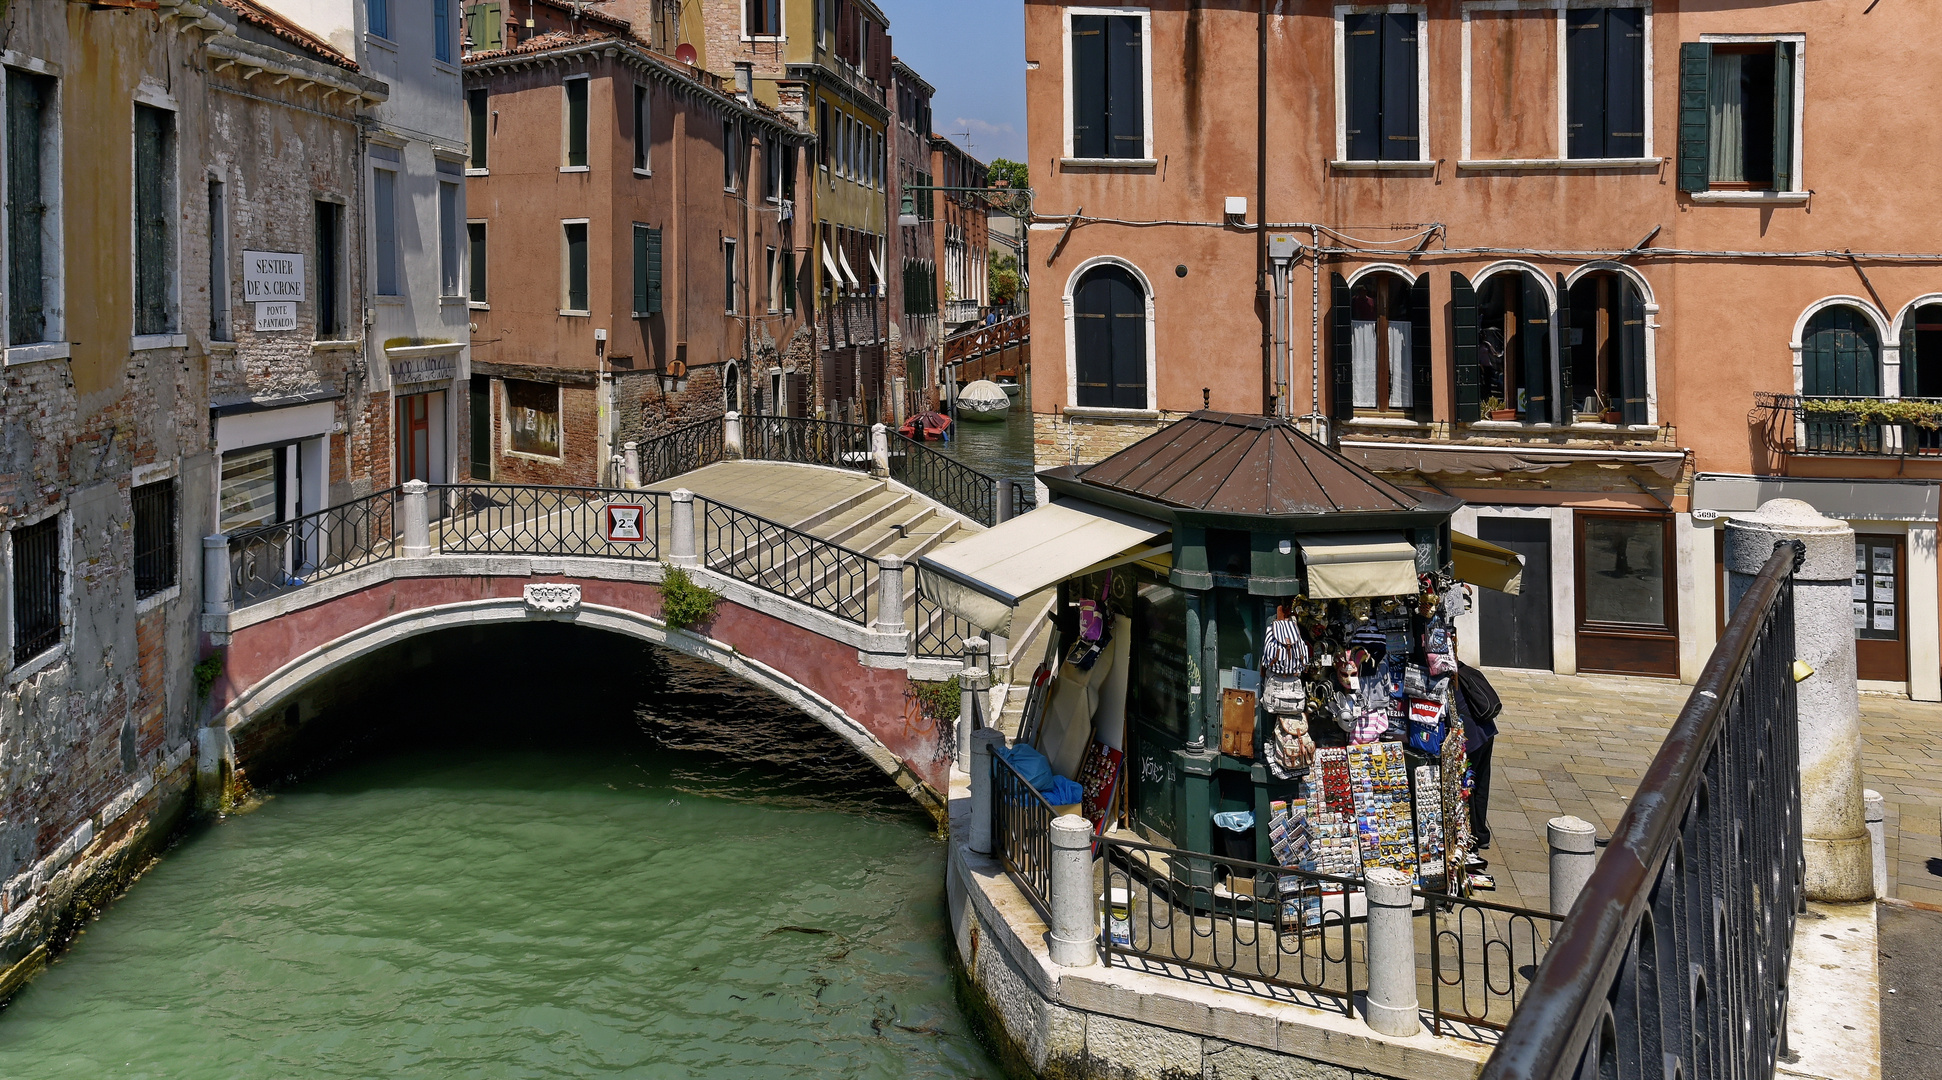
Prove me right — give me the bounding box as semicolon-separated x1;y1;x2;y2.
1066;14;1152;159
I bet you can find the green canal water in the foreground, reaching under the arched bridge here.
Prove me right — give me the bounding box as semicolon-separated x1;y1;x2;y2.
0;625;1000;1080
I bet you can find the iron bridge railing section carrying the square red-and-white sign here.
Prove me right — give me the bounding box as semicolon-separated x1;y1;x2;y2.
429;484;670;561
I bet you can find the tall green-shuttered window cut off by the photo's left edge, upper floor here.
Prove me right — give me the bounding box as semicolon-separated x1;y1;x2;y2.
6;68;60;346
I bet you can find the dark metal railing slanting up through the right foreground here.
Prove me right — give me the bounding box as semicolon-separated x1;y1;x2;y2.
1482;546;1804;1080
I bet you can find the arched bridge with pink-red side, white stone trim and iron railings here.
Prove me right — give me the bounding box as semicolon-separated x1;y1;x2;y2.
198;460;981;810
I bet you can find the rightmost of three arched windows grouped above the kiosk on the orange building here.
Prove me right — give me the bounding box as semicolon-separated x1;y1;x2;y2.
1557;272;1647;423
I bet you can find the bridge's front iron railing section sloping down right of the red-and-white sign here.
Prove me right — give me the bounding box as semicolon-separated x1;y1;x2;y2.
695;497;876;625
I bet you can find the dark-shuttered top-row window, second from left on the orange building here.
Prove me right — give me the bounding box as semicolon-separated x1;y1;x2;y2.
1342;12;1422;161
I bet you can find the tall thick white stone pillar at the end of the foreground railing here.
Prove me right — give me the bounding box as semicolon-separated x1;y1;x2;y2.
1726;499;1874;903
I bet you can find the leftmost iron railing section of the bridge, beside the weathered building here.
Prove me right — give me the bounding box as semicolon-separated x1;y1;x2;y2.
229;488;398;608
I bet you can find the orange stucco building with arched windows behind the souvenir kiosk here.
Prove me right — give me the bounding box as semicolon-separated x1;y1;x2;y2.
1025;0;1942;699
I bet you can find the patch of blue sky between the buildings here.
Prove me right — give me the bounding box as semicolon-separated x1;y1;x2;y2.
876;0;1025;161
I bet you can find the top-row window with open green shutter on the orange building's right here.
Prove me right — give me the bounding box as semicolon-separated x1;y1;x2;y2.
1680;41;1800;190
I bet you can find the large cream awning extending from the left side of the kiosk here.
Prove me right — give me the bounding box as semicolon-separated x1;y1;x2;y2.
917;501;1165;633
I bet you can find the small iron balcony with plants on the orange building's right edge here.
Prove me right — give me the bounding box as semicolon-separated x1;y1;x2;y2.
1756;392;1942;458
